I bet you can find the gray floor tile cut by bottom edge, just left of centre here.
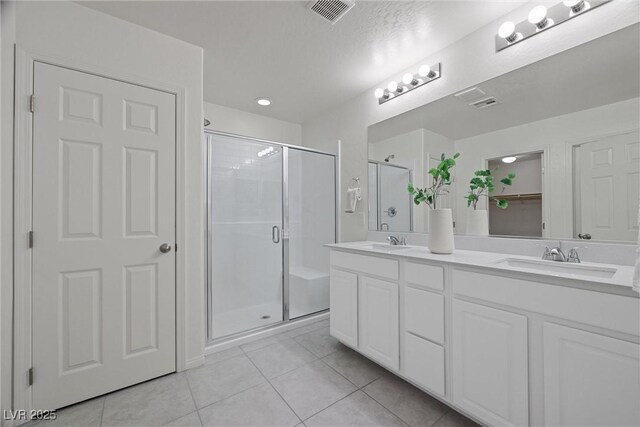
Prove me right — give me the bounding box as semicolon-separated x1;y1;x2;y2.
200;384;300;426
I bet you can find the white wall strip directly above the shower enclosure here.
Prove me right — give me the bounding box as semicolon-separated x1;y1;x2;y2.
204;102;302;145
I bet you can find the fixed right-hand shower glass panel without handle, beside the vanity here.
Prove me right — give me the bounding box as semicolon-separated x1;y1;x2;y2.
285;148;336;319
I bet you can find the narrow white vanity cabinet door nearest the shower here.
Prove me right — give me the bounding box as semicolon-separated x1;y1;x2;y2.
329;269;358;347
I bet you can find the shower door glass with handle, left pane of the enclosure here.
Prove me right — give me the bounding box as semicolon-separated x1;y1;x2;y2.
208;135;283;339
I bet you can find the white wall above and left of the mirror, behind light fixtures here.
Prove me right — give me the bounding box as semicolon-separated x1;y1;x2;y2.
302;0;639;241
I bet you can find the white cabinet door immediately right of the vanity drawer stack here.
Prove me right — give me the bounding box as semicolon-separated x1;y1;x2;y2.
452;299;529;426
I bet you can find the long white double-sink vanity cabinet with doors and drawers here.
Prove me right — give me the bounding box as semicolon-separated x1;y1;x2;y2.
330;249;640;426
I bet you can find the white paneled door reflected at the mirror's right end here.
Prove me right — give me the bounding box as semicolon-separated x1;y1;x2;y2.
575;132;640;241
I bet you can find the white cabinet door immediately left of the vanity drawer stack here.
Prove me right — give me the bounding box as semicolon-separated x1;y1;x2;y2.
358;276;400;370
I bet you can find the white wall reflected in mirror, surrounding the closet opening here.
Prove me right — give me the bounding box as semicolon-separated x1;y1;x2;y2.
455;98;640;238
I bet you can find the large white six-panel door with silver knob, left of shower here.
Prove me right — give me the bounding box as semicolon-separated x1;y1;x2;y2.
33;63;175;409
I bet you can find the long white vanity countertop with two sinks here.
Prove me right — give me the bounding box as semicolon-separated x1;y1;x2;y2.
325;241;640;298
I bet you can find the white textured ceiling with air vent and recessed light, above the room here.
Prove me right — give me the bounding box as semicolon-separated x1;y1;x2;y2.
79;0;526;123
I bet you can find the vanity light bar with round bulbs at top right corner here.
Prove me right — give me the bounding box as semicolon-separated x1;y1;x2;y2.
495;0;611;52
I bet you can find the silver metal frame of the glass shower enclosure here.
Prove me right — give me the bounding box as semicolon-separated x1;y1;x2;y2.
204;129;340;344
